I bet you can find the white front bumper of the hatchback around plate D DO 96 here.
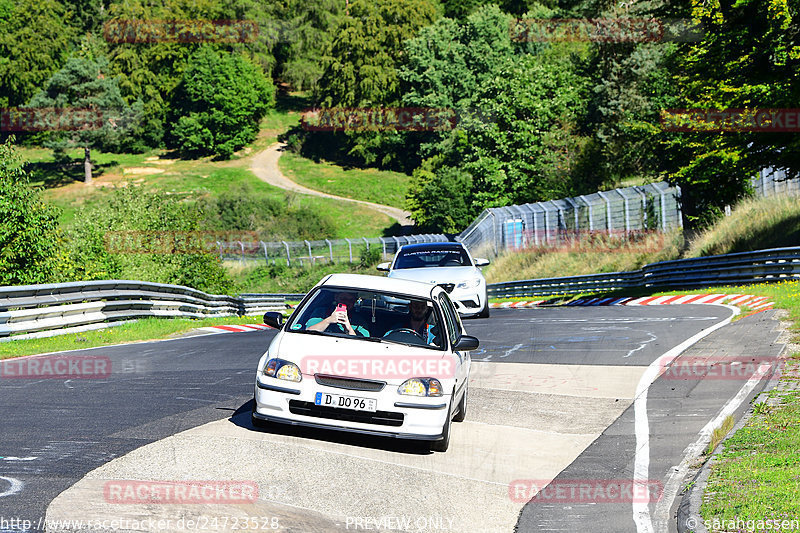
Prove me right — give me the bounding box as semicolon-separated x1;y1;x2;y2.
253;373;451;440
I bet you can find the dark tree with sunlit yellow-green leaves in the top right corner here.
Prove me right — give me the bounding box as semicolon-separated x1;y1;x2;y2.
665;0;800;224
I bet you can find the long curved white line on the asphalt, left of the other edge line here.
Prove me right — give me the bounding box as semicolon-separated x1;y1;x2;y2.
632;304;739;533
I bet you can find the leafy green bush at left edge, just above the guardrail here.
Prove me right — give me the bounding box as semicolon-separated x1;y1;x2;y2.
0;137;60;285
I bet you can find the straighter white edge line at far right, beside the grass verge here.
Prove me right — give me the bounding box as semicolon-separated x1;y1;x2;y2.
655;364;770;531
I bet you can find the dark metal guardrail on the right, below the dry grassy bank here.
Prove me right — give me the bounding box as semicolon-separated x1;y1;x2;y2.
487;247;800;298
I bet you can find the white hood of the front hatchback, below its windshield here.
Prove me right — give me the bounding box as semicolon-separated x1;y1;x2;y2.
270;331;452;385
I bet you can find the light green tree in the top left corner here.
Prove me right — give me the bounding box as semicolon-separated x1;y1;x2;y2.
0;0;76;107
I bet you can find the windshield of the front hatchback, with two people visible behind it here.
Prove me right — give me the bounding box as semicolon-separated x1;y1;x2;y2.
287;287;446;350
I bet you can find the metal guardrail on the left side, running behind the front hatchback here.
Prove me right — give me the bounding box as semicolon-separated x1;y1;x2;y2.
0;280;294;340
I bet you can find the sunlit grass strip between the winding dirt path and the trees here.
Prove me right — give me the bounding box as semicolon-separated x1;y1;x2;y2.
279;152;411;209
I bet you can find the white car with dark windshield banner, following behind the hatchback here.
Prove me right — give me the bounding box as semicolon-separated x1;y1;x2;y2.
377;242;489;318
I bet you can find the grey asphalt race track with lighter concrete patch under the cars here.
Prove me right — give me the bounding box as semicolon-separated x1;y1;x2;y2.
0;305;782;533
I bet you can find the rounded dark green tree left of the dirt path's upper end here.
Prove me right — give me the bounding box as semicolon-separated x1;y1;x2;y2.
170;47;275;158
